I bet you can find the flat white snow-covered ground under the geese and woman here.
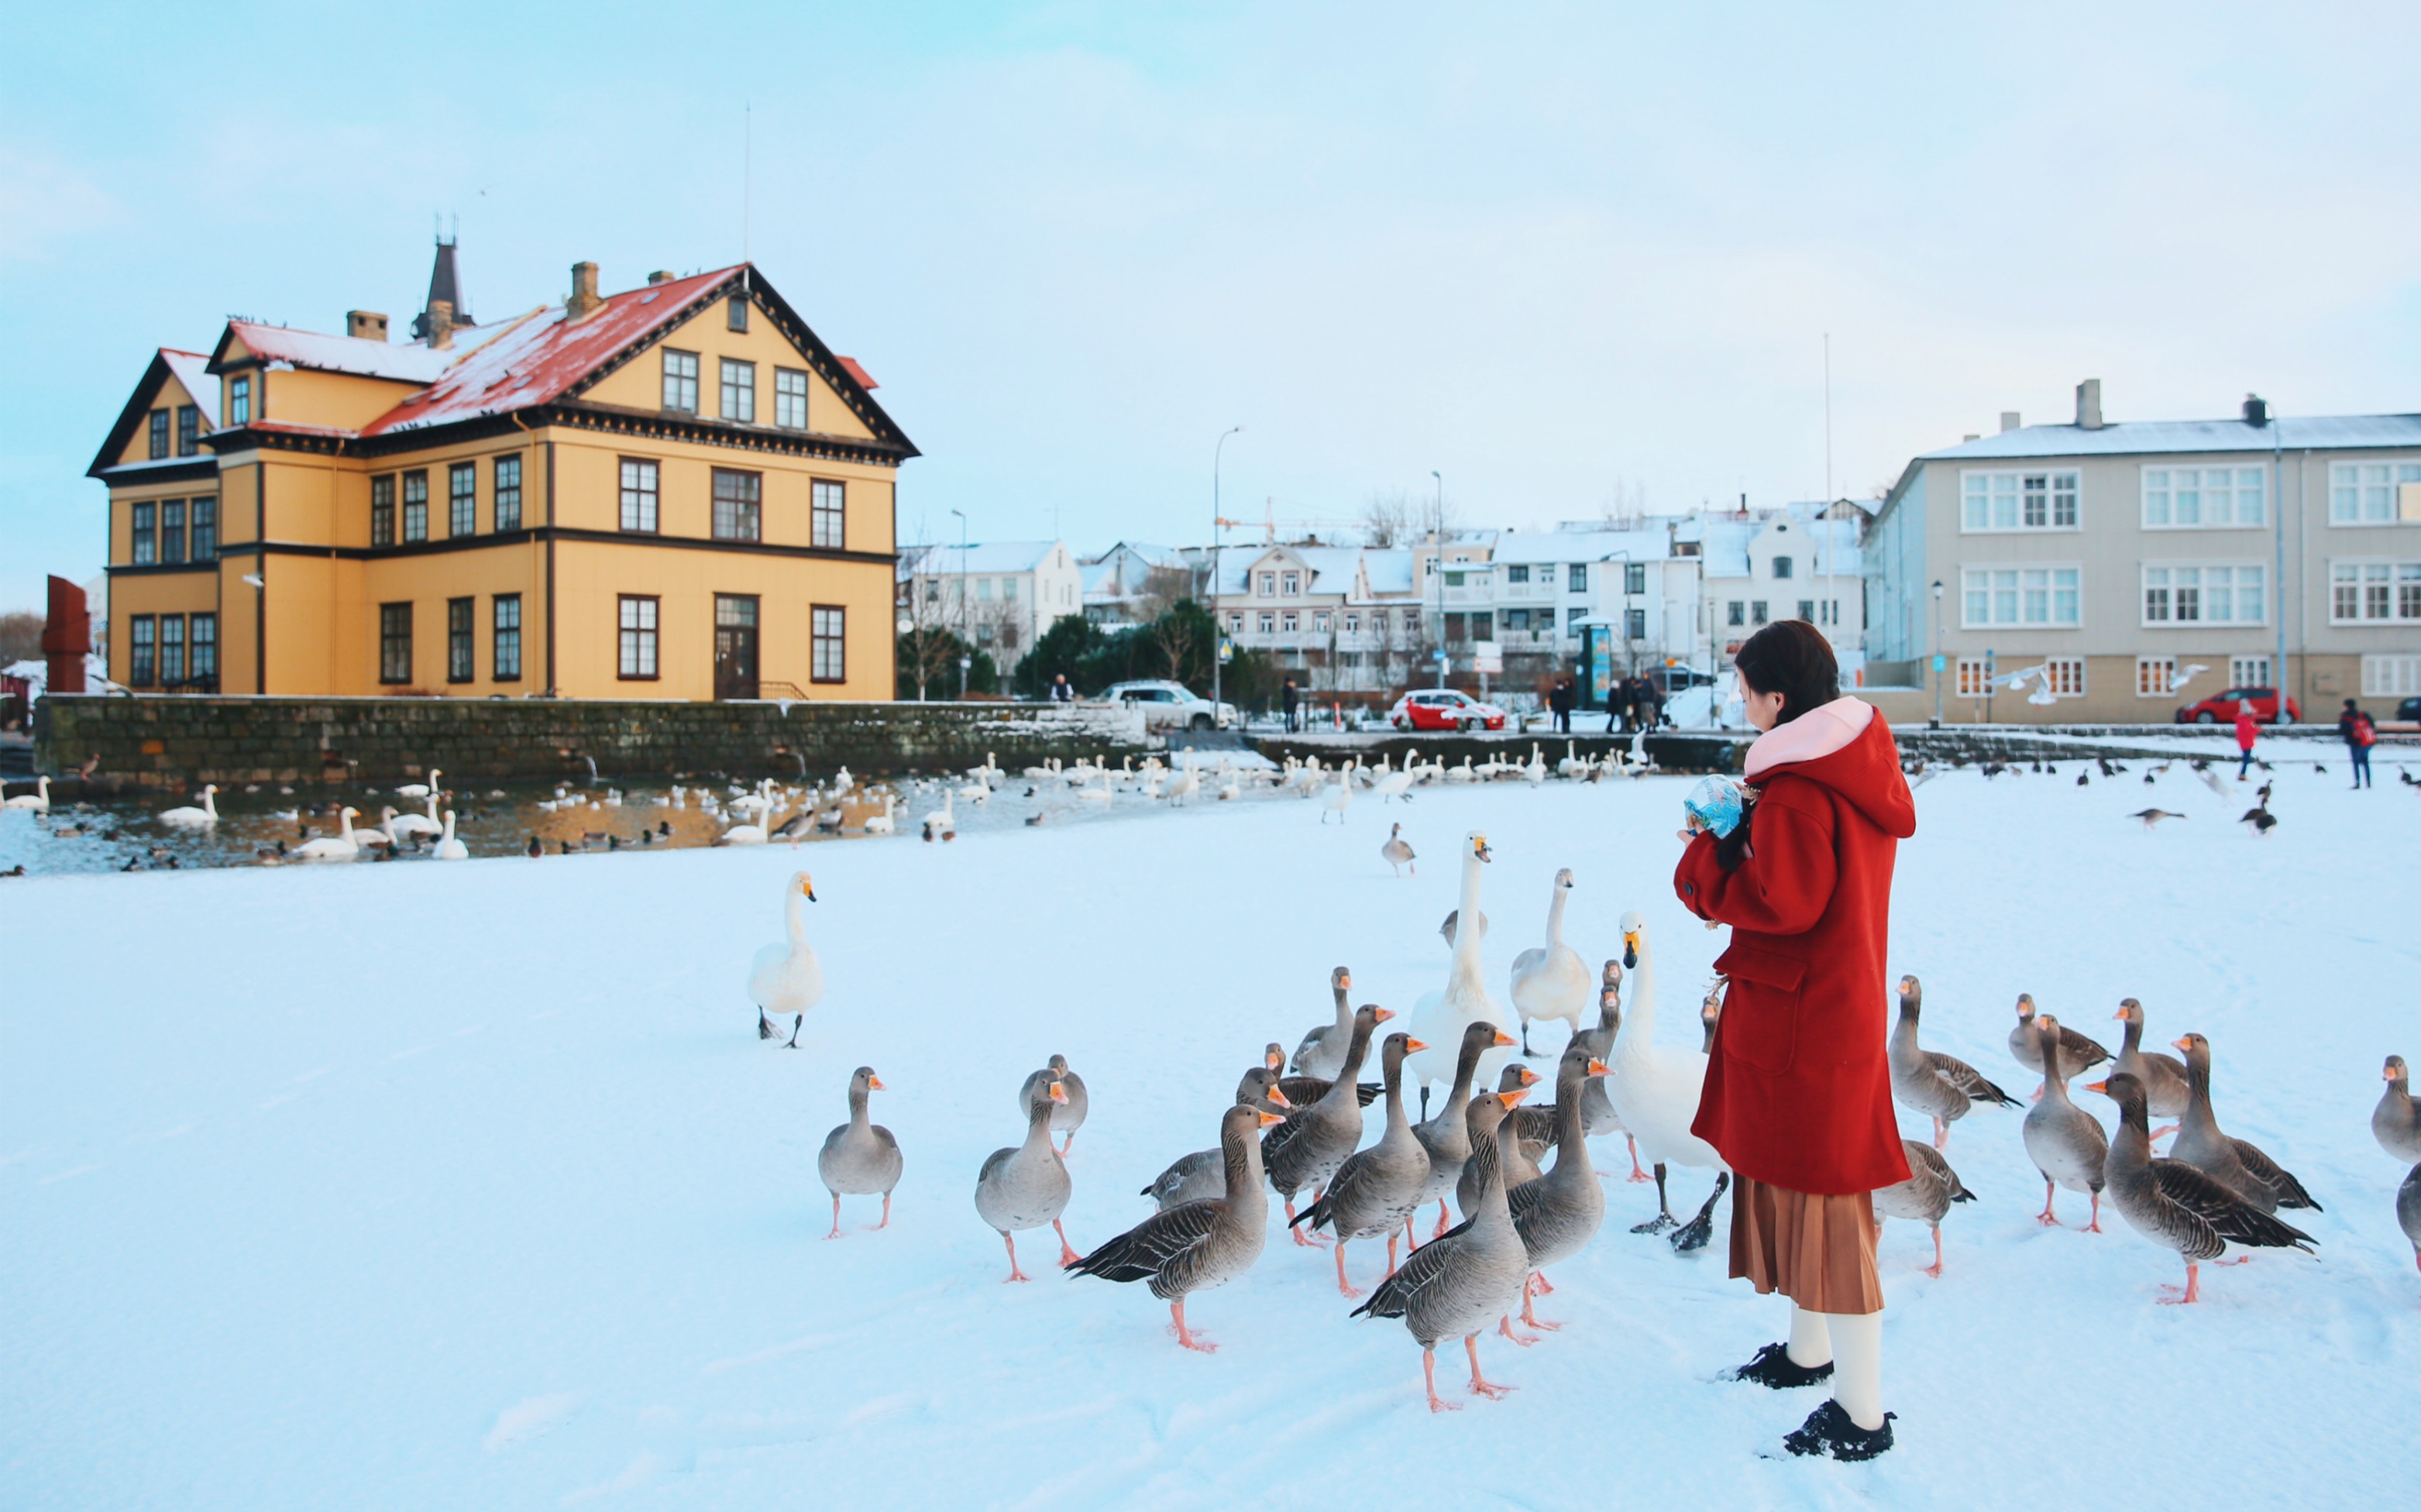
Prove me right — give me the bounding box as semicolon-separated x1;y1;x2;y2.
0;758;2421;1510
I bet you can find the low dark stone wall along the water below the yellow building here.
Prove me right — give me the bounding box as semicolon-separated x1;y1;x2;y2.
34;694;1147;791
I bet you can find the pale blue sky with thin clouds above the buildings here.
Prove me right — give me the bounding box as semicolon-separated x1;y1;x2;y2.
0;2;2421;607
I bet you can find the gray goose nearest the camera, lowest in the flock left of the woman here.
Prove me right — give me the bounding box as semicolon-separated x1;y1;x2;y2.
1353;1088;1530;1413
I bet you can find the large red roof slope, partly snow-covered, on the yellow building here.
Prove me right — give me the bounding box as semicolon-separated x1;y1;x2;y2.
360;266;738;435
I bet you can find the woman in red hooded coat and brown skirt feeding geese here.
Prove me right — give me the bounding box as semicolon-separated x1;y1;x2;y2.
1673;620;1917;1459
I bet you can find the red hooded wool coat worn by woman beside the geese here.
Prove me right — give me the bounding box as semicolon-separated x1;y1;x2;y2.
1673;711;1917;1195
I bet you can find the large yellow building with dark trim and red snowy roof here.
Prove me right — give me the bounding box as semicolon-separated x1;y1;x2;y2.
90;247;917;699
